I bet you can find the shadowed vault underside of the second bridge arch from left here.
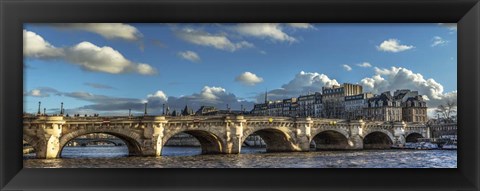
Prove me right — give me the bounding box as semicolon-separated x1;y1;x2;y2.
160;129;225;154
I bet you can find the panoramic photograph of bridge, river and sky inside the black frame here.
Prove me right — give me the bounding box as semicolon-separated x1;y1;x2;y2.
23;23;457;168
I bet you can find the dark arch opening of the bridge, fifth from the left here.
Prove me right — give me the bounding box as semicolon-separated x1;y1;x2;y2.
363;130;395;149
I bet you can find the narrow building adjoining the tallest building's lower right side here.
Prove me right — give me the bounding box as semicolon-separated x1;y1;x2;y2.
345;93;373;119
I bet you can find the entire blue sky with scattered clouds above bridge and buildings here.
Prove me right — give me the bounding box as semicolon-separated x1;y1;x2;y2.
23;23;457;115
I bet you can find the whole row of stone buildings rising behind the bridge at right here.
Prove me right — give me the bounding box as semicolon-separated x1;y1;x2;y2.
250;83;428;123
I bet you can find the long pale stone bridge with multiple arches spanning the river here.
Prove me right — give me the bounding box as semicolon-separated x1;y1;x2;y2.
23;115;430;158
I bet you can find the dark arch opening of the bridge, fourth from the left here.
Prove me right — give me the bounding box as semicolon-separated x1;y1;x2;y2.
310;129;349;150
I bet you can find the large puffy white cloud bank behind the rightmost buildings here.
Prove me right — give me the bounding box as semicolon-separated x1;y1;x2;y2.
360;67;457;108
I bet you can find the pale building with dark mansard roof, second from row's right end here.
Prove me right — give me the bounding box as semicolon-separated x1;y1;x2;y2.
363;91;402;122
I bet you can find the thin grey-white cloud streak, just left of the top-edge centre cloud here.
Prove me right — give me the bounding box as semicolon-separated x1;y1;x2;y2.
176;28;254;52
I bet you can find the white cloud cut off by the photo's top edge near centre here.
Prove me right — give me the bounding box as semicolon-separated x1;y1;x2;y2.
234;23;299;43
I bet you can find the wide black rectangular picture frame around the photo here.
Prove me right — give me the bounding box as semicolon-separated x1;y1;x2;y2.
0;0;480;190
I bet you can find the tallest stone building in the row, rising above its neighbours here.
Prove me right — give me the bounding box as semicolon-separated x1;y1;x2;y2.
322;83;363;118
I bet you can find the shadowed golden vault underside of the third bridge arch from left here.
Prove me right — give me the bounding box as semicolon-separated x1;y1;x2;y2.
241;126;301;152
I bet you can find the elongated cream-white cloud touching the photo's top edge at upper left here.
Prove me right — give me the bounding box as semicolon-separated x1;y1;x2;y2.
53;23;142;41
